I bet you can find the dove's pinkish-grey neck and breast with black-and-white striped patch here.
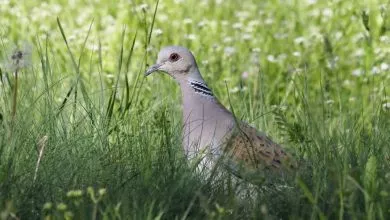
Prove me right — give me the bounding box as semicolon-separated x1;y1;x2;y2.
179;77;234;155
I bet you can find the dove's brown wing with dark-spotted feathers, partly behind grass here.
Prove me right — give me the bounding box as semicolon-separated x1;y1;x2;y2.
224;123;296;174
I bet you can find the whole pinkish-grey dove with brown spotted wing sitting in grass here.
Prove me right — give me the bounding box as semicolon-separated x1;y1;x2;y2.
145;46;296;177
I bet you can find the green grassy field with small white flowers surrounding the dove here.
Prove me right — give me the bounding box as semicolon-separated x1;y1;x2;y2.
0;0;390;219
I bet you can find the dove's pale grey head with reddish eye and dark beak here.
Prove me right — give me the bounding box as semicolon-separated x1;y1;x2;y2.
145;46;200;79
